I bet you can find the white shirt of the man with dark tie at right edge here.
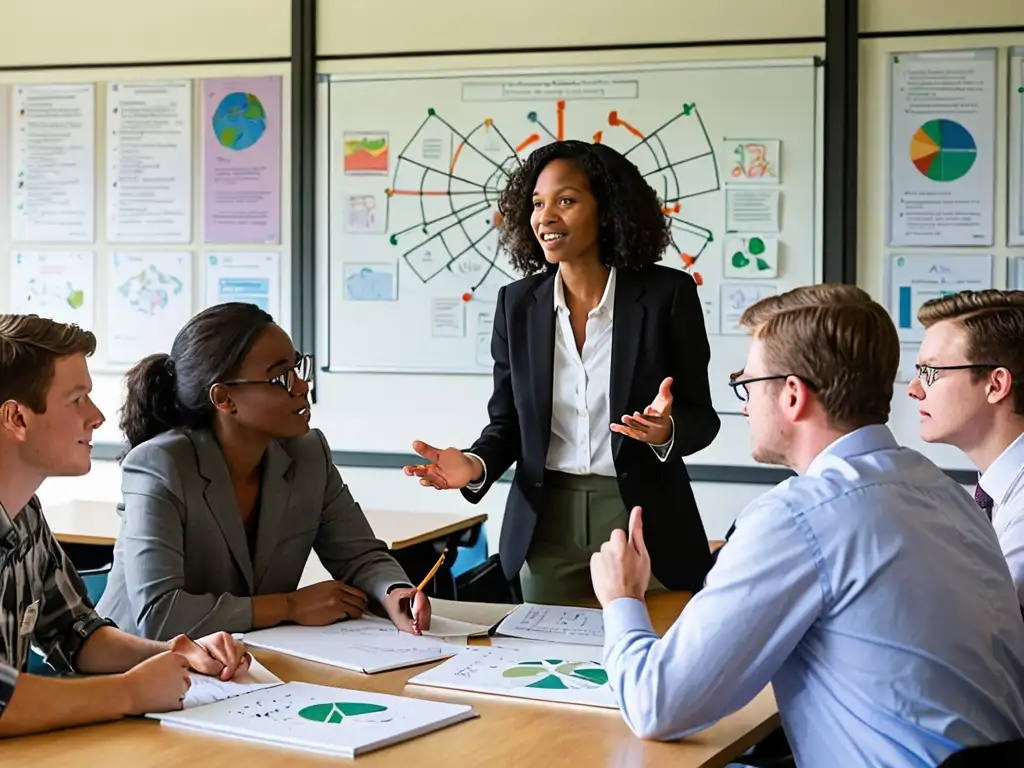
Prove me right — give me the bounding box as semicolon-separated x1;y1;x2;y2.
978;434;1024;605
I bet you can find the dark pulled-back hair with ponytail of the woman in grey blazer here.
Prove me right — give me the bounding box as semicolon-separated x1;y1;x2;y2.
120;302;273;456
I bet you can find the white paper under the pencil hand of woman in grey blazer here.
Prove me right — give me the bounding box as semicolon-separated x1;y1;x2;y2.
245;618;458;675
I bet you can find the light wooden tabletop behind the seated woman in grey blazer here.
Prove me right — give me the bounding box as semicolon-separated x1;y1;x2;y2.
43;502;487;550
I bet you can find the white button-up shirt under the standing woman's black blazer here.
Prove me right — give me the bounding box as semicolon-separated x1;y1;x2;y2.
466;267;676;492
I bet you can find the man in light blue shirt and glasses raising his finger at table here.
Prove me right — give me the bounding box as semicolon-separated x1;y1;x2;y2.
591;285;1024;768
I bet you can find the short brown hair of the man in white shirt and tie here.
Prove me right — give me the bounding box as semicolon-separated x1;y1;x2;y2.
918;289;1024;415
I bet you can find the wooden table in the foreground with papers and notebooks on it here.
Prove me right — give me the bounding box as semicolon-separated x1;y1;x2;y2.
6;593;778;768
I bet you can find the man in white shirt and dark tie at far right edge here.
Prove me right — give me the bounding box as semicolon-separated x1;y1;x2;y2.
908;290;1024;606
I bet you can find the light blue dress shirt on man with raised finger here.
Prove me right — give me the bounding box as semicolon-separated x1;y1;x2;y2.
604;426;1024;768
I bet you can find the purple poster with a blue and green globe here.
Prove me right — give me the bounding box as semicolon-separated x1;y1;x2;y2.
202;76;283;244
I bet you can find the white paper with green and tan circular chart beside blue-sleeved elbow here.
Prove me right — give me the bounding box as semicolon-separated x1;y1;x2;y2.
409;644;618;709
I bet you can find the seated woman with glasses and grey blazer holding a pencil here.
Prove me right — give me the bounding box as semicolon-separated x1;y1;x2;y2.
97;303;430;639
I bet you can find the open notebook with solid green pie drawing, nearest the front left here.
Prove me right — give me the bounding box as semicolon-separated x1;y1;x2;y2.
146;664;476;758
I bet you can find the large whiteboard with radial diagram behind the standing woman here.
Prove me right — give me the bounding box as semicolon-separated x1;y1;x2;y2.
323;58;821;413
